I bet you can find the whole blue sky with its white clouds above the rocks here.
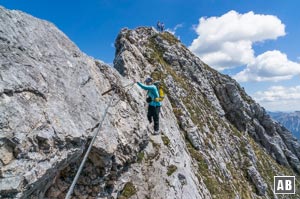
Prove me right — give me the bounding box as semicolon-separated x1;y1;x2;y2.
0;0;300;111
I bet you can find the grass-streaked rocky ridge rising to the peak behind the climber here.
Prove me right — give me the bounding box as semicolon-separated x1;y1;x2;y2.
114;28;300;198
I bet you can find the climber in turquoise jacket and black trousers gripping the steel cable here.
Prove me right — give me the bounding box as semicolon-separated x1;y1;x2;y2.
137;77;161;135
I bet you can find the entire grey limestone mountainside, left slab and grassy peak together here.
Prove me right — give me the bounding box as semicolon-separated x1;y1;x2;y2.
0;7;300;199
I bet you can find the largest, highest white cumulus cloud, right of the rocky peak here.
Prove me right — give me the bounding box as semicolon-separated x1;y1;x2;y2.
189;11;286;70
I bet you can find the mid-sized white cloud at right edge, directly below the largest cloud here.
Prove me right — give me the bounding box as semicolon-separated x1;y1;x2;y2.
234;50;300;82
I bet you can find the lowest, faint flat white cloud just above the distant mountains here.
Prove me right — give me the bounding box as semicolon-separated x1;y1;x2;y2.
254;85;300;111
